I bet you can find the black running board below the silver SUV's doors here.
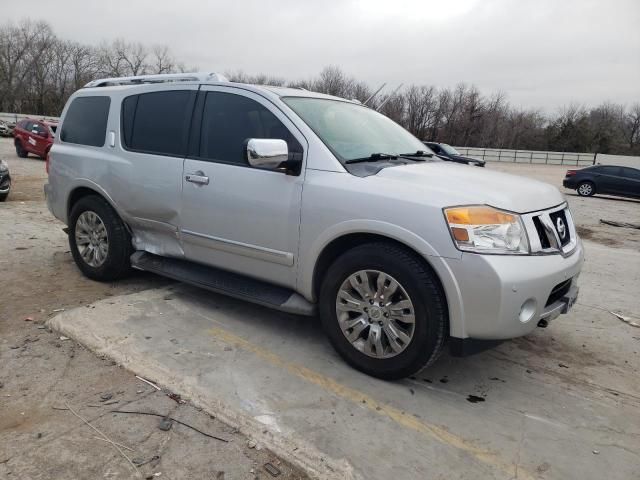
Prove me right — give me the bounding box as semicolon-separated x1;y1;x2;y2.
131;251;316;316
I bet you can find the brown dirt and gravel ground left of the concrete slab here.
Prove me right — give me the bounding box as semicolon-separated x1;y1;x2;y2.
0;139;307;480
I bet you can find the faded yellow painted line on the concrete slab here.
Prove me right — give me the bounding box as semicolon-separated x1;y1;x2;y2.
209;327;535;480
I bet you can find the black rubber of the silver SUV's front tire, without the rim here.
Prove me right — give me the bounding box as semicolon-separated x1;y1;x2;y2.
319;242;448;380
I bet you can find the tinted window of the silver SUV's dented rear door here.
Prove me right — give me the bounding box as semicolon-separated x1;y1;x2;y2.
122;90;195;156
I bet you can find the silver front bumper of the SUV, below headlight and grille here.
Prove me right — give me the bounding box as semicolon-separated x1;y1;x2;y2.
447;240;584;340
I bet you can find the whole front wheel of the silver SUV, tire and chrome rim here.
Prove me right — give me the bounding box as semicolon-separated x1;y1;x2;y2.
319;242;448;380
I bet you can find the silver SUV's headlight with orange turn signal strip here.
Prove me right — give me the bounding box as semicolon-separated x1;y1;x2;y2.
444;205;529;255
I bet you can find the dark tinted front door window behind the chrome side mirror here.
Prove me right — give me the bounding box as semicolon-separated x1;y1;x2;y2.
199;92;302;165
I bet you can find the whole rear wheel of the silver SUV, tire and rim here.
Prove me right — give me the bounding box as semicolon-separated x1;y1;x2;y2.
69;195;133;282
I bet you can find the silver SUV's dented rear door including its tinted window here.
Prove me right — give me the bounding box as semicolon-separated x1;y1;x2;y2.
117;85;198;257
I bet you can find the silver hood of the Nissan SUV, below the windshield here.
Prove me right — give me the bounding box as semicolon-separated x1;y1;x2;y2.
376;162;565;213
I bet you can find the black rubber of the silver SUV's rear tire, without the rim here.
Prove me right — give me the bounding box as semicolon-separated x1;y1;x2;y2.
69;195;133;282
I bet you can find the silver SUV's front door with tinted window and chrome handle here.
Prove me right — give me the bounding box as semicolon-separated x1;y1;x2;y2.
180;86;306;287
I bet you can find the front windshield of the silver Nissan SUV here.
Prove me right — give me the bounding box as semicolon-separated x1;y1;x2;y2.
282;97;430;162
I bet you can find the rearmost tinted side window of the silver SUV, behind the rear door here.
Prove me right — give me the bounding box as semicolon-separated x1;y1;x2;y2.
60;97;111;147
